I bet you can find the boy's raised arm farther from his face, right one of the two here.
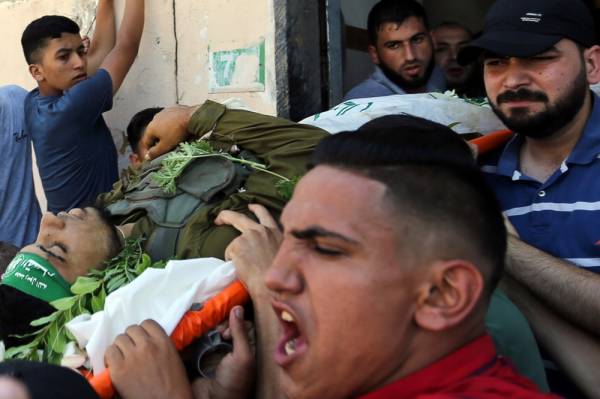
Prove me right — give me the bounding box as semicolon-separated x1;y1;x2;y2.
100;0;144;94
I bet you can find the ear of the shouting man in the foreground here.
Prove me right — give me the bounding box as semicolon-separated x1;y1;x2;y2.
415;260;484;331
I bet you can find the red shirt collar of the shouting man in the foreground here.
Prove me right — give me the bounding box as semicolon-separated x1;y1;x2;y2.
359;334;497;399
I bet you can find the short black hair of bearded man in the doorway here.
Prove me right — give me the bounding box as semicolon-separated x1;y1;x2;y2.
367;0;429;45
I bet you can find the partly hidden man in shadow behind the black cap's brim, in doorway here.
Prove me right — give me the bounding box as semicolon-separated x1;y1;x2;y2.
431;22;485;98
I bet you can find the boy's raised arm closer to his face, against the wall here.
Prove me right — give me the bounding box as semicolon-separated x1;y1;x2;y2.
87;0;116;75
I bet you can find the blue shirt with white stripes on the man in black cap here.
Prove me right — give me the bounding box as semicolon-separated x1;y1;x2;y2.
481;95;600;273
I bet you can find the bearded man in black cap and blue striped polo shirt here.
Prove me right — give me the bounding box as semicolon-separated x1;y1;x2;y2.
459;0;600;397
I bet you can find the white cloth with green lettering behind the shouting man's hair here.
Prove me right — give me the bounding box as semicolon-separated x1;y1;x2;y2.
300;92;506;134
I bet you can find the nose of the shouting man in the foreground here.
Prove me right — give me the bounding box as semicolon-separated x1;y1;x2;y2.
265;241;304;294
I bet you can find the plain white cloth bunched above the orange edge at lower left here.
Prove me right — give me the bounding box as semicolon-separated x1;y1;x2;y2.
67;258;235;374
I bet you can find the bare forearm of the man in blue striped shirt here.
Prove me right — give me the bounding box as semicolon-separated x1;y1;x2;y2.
506;235;600;335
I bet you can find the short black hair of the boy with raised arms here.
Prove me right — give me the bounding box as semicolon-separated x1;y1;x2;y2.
21;15;79;64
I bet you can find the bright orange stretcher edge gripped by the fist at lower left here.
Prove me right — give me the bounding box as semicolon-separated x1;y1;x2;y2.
89;281;250;399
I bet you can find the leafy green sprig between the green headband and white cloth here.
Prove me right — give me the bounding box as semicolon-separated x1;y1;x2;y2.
5;238;166;364
